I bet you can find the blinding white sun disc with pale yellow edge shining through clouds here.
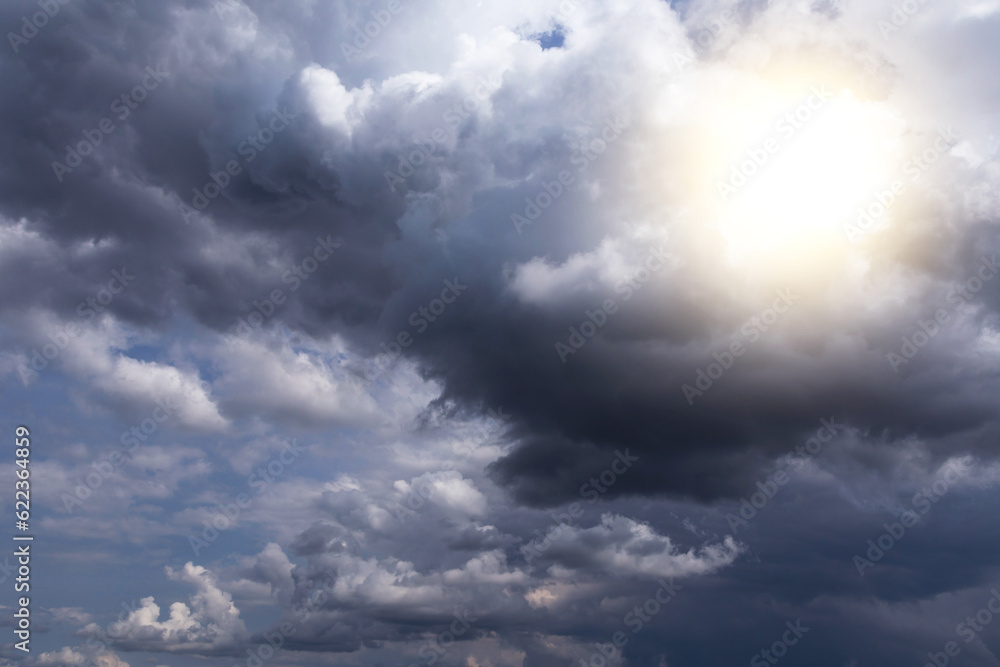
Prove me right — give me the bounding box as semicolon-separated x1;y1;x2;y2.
693;73;901;280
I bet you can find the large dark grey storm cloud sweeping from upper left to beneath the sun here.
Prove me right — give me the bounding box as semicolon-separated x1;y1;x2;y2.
0;3;998;503
